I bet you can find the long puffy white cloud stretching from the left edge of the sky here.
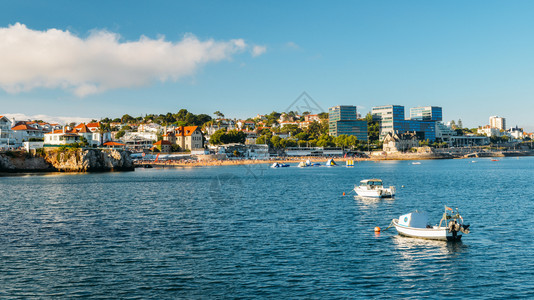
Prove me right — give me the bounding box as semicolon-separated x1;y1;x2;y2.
0;23;253;97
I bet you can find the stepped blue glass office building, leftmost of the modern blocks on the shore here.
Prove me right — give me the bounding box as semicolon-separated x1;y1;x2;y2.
328;105;367;141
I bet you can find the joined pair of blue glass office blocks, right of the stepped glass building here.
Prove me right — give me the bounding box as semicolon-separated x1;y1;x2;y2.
372;105;443;141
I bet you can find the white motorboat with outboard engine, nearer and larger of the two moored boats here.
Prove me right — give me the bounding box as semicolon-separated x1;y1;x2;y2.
392;206;469;241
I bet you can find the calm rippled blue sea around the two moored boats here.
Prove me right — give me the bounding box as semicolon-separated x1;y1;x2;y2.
0;158;534;299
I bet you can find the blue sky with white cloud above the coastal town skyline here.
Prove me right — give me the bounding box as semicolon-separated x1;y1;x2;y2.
0;1;534;130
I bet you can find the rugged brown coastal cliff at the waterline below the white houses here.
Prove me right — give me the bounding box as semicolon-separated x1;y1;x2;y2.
0;148;134;173
